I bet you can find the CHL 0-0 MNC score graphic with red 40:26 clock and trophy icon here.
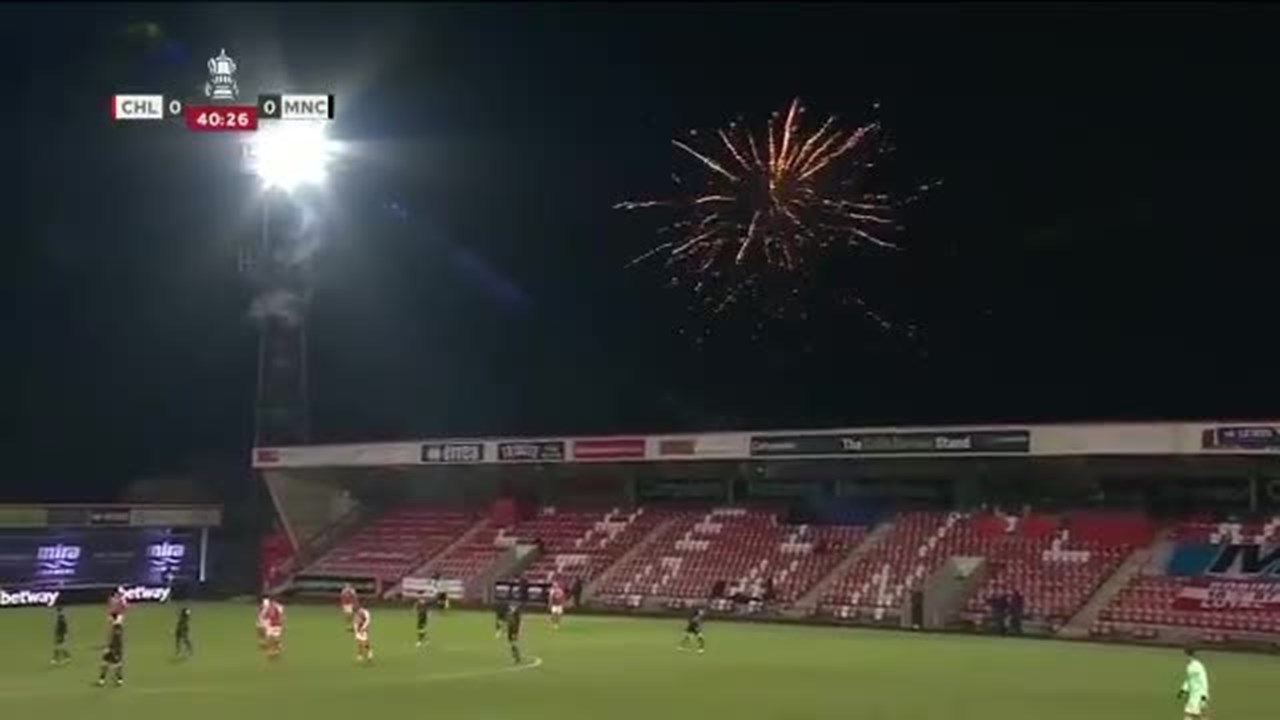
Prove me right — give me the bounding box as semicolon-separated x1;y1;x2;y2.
111;49;334;132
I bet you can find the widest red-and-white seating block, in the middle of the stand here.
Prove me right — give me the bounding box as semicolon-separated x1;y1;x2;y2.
596;507;867;606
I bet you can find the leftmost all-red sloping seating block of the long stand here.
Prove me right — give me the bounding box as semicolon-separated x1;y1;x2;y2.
302;507;477;583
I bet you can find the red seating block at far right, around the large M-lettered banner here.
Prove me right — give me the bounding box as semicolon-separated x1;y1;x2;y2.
1092;516;1280;639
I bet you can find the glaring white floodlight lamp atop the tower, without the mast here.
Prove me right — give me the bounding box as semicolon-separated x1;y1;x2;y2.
246;122;334;192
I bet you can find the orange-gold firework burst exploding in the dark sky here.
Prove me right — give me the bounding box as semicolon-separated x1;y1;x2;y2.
614;100;926;320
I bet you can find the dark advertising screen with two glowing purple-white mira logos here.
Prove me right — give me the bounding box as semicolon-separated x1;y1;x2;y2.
0;529;201;591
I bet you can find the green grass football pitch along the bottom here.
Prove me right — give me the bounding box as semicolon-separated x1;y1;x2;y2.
0;603;1280;720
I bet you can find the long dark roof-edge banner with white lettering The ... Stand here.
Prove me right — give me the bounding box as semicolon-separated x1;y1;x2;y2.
751;430;1032;457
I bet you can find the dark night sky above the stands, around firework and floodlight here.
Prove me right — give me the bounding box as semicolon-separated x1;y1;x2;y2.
10;4;1280;500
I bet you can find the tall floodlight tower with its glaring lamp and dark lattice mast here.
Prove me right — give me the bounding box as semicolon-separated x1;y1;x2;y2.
241;122;332;447
